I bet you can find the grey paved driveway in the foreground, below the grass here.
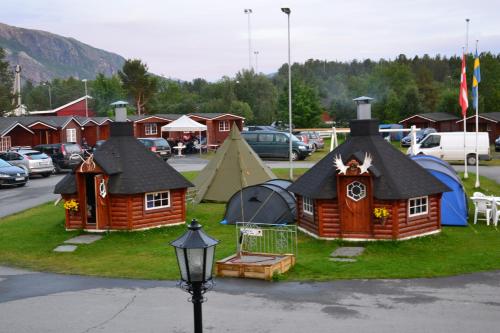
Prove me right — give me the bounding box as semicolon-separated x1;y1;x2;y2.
0;262;500;333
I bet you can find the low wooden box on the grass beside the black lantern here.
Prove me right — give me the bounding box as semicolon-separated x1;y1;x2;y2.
215;253;295;281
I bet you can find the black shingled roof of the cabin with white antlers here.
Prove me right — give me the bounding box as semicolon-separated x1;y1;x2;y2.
288;120;450;200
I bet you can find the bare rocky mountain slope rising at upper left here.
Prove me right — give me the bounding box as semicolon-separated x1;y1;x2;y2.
0;23;125;82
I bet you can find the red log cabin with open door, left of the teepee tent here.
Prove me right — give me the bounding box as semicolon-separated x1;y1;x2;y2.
54;122;193;231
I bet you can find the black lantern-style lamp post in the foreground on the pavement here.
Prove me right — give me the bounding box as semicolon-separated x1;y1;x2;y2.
170;219;219;333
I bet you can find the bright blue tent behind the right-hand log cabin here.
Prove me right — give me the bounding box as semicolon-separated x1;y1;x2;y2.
411;155;469;226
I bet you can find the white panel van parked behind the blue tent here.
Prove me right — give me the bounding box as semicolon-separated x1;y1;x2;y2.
408;132;491;165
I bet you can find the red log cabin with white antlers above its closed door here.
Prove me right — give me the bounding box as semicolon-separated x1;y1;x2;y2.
288;119;450;240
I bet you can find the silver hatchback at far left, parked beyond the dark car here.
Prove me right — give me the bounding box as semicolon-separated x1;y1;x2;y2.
0;149;54;177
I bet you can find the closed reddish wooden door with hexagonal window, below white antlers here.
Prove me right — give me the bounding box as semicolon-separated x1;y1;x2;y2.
337;176;371;238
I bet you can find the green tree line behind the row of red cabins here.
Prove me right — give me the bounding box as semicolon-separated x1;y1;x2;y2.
0;49;500;127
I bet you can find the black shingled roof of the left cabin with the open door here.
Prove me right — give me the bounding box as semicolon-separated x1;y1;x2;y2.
54;123;193;194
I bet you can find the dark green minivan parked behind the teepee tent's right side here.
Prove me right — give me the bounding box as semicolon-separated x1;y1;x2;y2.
242;131;312;161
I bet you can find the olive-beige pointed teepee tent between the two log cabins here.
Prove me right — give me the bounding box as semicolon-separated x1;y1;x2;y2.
193;124;276;203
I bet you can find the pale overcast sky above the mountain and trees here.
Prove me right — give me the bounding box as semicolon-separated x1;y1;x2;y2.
0;0;500;81
